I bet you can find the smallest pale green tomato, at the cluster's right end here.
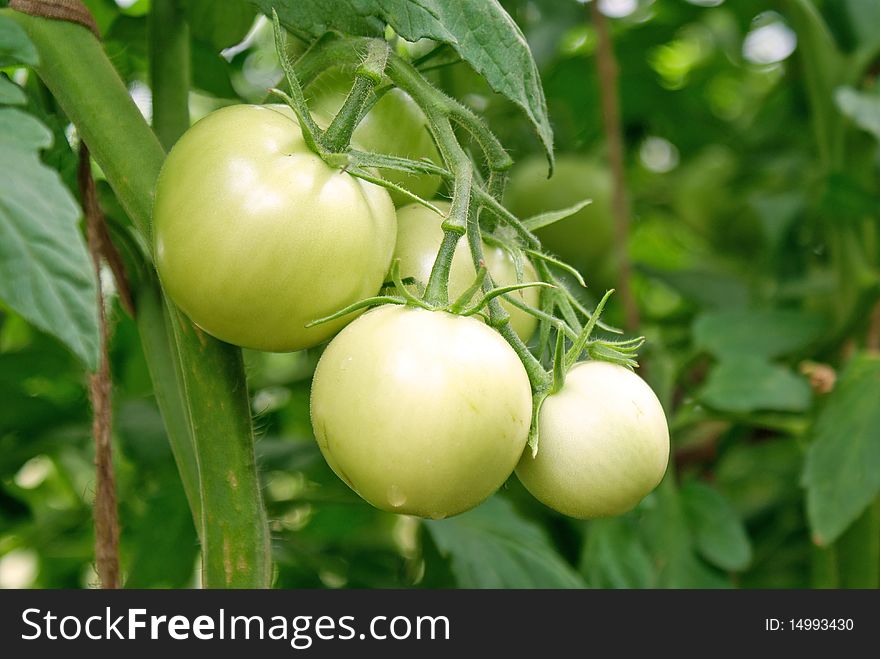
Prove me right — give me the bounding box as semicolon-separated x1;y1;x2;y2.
516;361;669;519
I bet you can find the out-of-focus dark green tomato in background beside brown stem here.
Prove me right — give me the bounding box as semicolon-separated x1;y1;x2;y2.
504;155;614;290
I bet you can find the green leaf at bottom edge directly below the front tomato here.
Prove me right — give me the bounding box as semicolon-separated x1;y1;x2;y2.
425;496;585;588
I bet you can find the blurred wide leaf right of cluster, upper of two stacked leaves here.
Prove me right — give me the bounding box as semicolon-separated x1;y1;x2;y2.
693;309;826;359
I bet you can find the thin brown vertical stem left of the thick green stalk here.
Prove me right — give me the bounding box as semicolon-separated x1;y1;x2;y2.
77;144;120;588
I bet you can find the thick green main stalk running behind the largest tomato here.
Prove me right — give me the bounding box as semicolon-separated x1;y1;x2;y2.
9;9;271;588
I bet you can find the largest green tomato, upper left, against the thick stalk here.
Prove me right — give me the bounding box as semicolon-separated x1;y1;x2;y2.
153;105;397;351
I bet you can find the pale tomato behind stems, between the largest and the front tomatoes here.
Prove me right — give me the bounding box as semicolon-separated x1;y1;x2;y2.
394;201;540;341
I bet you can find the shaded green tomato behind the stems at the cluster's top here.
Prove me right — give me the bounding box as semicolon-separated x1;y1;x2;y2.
306;69;443;206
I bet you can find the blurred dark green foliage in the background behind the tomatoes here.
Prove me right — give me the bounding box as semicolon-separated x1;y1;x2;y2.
0;0;880;588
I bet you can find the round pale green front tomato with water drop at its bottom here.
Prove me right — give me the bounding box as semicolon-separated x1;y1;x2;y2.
311;306;532;519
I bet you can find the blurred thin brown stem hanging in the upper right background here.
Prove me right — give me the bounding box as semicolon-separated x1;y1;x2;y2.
589;0;639;330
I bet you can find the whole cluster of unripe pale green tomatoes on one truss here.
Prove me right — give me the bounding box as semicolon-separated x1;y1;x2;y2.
154;95;669;519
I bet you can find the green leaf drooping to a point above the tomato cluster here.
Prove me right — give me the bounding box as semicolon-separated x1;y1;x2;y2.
250;0;553;165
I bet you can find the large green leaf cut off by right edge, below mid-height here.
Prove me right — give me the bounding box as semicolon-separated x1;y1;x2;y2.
802;354;880;545
